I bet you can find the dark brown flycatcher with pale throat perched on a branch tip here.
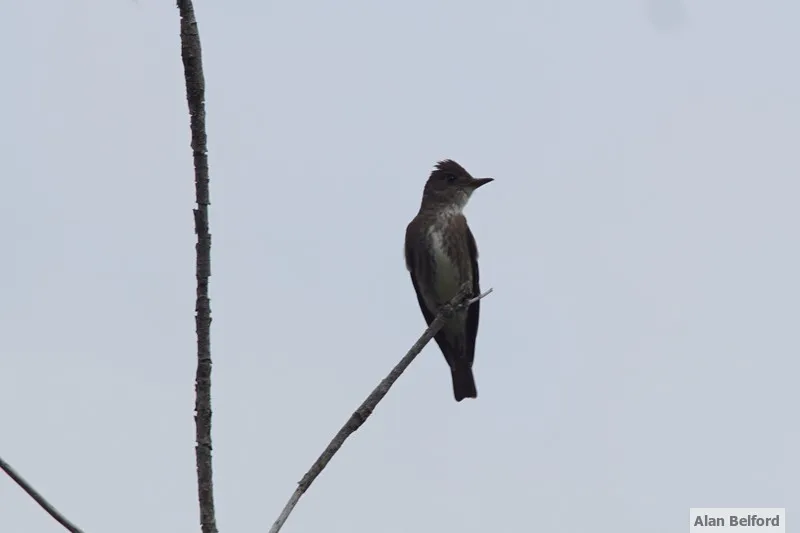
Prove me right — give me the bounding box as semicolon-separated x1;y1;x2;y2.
405;159;493;402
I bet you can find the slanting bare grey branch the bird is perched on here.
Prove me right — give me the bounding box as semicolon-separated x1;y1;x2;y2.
269;284;492;533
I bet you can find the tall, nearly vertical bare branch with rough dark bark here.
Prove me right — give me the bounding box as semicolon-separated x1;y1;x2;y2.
177;0;217;533
